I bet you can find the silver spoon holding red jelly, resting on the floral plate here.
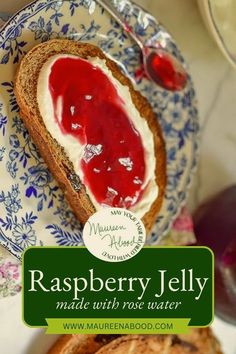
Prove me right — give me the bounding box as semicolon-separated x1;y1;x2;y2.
96;0;188;91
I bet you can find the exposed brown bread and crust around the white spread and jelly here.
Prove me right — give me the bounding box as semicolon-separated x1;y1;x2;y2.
15;39;166;232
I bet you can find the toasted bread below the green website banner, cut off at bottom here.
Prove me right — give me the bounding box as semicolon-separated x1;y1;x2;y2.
48;328;222;354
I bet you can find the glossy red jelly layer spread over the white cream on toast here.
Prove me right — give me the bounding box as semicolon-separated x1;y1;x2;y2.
49;57;145;208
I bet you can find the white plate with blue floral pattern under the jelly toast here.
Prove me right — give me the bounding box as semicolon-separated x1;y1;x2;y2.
0;0;199;258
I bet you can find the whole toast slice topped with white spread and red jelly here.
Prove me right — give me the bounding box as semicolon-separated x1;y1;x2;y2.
15;39;166;232
